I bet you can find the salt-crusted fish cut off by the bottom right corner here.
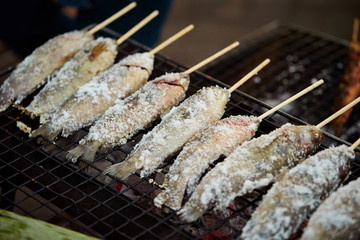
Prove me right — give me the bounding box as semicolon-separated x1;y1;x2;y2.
301;174;360;240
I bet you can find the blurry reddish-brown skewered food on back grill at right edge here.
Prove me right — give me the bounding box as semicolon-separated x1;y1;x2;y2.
331;19;360;136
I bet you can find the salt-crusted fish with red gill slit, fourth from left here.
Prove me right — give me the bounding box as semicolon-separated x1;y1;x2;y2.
67;73;189;162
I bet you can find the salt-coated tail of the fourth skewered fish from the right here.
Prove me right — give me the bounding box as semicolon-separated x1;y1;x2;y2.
154;188;184;211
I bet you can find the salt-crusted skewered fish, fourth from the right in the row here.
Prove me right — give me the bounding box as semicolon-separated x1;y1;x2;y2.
154;116;260;210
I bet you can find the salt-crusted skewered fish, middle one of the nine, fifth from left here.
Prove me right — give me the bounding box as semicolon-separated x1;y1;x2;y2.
104;87;230;179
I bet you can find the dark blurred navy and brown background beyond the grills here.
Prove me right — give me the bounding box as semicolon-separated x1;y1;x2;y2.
0;0;360;71
